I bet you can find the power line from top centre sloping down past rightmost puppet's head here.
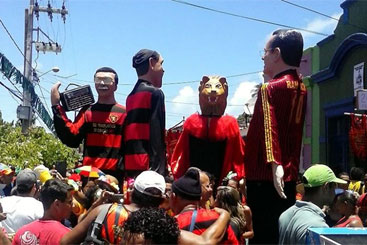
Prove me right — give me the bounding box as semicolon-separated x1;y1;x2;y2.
171;0;329;37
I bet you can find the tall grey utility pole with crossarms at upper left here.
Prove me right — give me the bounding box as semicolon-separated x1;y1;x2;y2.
18;0;68;134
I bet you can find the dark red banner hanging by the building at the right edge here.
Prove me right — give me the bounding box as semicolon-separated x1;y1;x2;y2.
349;114;367;160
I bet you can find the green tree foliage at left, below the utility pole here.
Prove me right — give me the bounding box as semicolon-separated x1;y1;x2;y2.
0;119;80;168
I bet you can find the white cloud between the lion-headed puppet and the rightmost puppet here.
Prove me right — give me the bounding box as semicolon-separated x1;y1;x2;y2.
226;81;258;117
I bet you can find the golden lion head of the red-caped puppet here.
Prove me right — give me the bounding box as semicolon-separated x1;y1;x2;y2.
199;76;228;116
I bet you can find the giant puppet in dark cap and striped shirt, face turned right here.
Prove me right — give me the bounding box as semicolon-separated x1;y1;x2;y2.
124;49;167;177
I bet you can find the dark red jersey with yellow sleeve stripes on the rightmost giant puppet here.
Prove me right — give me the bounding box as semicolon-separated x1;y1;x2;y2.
245;70;307;182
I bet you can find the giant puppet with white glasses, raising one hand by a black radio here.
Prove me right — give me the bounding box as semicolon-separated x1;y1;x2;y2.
51;67;126;179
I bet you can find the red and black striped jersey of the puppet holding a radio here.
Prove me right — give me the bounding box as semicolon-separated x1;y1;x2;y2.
53;103;126;170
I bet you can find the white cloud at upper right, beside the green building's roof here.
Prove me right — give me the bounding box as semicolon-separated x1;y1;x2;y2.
301;13;342;39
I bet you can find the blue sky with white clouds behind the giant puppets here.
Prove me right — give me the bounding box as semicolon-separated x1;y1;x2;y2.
0;0;343;128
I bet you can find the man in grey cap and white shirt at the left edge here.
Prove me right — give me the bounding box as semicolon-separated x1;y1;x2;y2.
0;169;43;234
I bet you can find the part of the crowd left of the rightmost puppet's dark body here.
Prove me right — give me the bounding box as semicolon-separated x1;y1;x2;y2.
0;164;253;244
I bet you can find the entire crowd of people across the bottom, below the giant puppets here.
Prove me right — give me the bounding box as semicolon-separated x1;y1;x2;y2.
0;164;367;244
